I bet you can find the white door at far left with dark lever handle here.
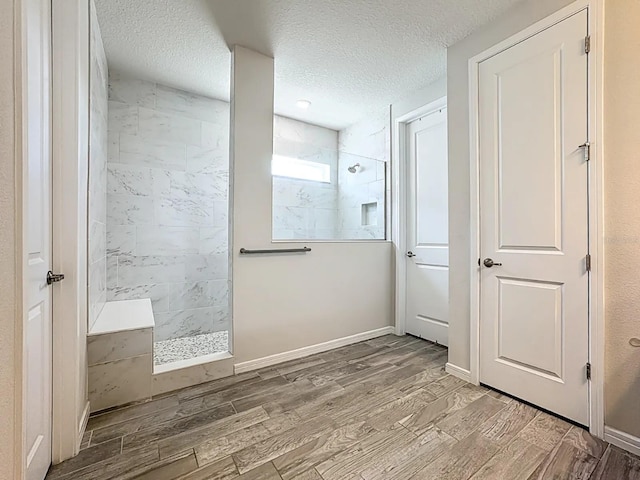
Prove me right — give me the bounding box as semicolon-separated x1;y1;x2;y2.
23;0;52;480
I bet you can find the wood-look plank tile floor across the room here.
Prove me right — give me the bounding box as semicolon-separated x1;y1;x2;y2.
47;336;640;480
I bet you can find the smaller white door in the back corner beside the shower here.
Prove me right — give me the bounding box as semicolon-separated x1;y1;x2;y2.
405;107;449;345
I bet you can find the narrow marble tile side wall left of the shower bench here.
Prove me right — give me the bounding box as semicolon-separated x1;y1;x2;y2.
88;2;108;329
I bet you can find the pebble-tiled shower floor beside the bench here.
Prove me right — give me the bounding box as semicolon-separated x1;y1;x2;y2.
153;330;229;365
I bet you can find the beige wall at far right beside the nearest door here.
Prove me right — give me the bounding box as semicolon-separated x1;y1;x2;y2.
604;0;640;437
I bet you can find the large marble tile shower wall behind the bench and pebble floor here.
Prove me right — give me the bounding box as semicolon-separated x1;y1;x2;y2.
107;73;230;341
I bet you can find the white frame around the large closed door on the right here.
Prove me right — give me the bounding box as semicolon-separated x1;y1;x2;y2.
468;0;604;438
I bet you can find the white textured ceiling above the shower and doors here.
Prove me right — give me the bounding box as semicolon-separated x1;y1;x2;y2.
95;0;524;128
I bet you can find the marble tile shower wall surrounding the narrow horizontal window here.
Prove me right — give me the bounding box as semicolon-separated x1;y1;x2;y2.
273;116;338;240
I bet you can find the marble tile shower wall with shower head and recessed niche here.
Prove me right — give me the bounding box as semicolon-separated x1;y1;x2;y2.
336;109;391;239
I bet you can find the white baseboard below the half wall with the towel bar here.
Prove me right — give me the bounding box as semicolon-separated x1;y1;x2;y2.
234;327;395;374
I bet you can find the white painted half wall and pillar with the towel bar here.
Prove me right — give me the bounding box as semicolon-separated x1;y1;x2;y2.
231;47;393;363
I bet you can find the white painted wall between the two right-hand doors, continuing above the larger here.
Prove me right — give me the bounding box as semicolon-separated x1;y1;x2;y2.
447;0;571;370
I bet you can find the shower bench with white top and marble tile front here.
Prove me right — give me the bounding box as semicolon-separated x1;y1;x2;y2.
87;298;155;412
